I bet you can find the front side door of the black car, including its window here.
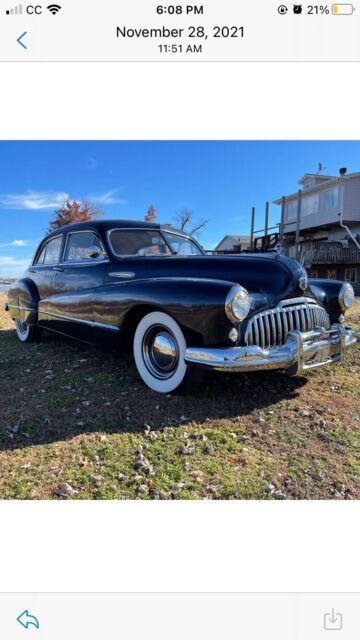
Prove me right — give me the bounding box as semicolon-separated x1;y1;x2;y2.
48;230;108;342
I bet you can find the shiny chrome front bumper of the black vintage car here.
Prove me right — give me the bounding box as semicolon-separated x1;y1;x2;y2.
185;324;356;375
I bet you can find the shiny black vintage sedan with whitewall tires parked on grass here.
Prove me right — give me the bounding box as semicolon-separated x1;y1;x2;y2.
6;220;356;393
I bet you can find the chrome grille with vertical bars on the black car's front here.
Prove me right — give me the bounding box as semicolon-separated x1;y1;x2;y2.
245;298;330;349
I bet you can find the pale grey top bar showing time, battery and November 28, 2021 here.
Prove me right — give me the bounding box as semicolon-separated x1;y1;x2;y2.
0;0;360;62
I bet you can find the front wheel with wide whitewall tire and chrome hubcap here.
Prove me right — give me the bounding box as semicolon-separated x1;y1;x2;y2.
133;311;201;393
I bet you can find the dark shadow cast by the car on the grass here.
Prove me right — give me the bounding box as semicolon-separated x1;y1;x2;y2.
0;330;306;451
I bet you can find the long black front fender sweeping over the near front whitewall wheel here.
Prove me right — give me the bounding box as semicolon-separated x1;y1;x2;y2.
94;278;236;345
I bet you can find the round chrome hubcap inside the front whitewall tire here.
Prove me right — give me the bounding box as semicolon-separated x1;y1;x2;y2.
143;327;179;379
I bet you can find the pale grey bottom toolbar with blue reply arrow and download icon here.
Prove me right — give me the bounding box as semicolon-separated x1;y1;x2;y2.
0;593;360;640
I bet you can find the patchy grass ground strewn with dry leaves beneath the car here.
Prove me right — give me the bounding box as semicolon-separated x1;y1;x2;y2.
0;294;360;500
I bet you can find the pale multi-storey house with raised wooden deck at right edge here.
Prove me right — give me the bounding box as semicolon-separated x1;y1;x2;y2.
274;169;360;295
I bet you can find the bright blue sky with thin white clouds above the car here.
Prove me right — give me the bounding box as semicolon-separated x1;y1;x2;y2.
0;141;360;276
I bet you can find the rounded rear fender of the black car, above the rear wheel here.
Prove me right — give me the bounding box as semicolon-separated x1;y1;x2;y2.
7;278;39;325
